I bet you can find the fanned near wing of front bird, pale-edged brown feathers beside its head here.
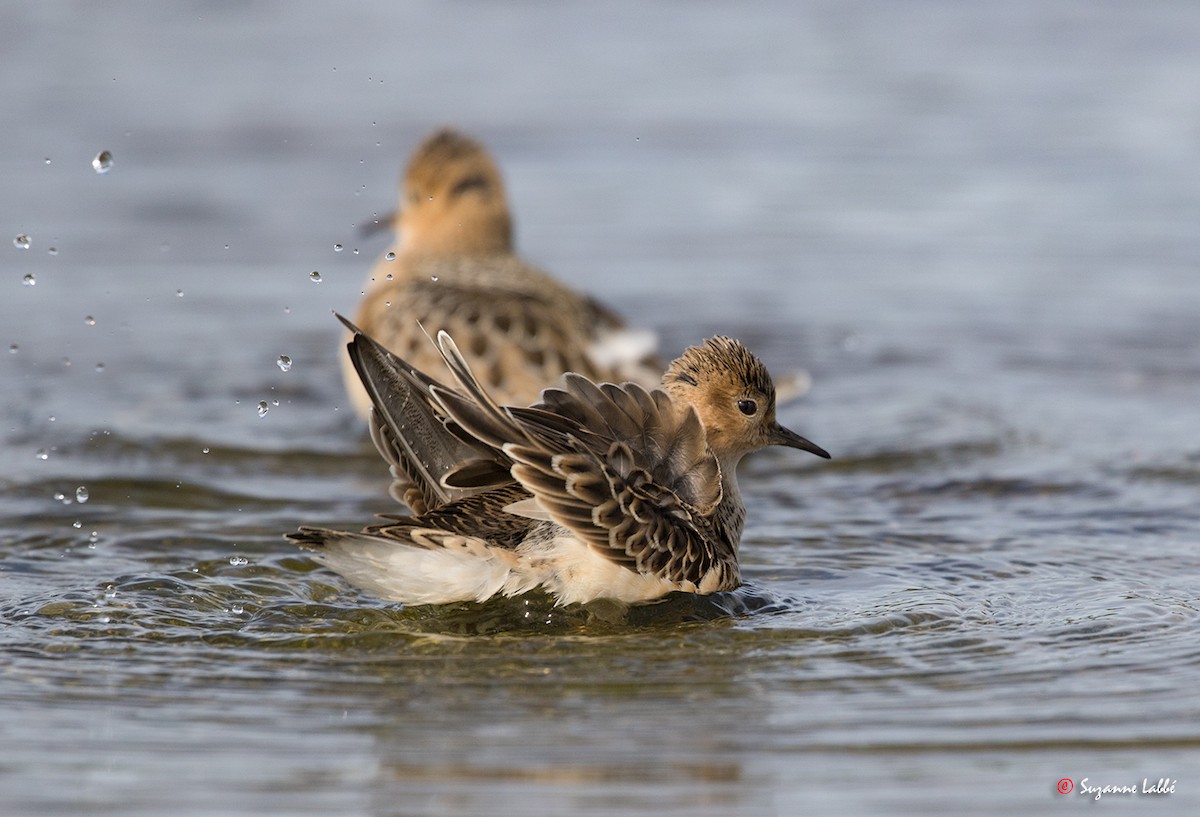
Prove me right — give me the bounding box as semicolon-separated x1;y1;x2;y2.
431;332;738;589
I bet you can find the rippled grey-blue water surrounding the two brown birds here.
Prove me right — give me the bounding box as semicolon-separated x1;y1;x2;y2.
0;0;1200;816
